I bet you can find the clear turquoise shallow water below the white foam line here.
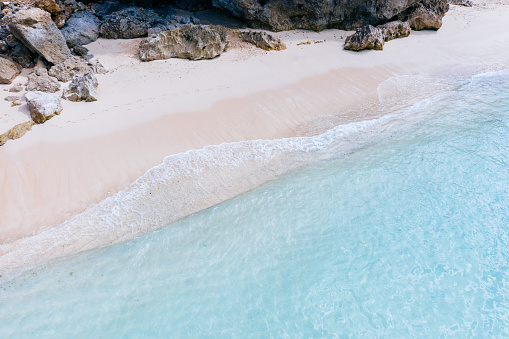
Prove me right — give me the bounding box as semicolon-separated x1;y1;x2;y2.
0;72;509;338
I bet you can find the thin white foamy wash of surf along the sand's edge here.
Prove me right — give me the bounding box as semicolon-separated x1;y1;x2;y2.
0;67;504;270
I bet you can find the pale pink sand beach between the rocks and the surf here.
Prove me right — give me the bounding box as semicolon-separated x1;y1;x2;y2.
0;1;509;268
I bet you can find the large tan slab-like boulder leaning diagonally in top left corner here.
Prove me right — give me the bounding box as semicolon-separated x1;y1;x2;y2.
5;8;71;64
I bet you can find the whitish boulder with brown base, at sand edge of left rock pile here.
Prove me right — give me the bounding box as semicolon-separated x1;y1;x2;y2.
25;91;62;124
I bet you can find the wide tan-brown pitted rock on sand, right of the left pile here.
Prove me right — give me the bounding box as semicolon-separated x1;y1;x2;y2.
140;25;228;61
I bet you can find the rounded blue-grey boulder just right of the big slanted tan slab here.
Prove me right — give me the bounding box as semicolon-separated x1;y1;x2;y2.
61;11;100;48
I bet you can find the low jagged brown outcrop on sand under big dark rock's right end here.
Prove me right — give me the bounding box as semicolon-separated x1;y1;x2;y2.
345;21;411;51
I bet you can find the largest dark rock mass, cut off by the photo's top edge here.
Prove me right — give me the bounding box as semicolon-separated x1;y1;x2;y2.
208;0;419;31
